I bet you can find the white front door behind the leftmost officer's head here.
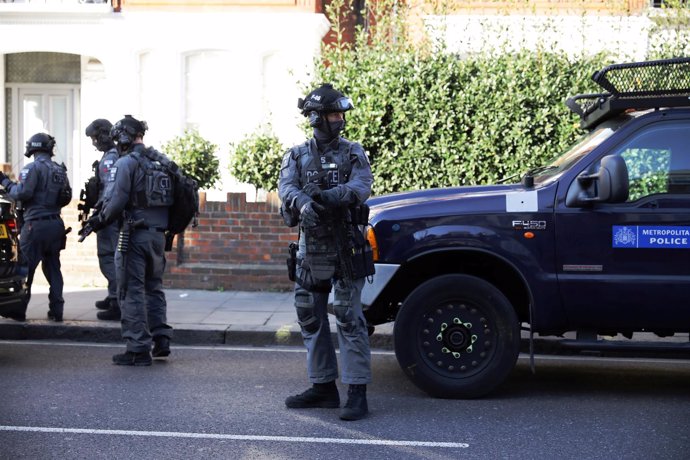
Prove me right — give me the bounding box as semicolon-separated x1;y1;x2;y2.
12;85;76;183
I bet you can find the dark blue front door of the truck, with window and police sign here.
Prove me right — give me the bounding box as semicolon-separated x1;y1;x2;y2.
555;120;690;331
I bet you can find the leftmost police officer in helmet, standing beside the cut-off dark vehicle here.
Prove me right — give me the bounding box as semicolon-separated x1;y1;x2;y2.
0;133;72;322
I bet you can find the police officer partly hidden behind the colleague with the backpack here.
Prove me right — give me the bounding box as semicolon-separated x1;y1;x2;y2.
80;118;120;320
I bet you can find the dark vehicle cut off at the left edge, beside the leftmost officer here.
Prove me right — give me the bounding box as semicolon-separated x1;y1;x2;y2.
0;189;27;321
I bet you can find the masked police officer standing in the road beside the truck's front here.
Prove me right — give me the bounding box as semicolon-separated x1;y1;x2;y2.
279;84;373;420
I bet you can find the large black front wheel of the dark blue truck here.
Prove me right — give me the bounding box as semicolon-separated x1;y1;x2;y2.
393;275;520;398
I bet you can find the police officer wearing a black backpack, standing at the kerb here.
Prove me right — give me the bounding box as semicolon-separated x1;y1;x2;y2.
87;115;173;366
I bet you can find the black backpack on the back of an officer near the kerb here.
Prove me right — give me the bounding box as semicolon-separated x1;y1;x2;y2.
133;148;199;235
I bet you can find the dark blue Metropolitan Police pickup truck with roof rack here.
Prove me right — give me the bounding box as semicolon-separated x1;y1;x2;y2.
362;58;690;398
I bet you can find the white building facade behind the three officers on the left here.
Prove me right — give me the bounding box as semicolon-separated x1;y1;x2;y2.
0;0;329;199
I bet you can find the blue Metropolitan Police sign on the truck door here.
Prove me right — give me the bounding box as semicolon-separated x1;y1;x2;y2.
612;225;690;249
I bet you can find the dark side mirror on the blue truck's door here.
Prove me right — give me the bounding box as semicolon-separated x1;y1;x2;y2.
565;155;629;207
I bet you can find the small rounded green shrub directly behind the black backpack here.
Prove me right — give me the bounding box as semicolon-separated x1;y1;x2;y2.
163;130;220;189
